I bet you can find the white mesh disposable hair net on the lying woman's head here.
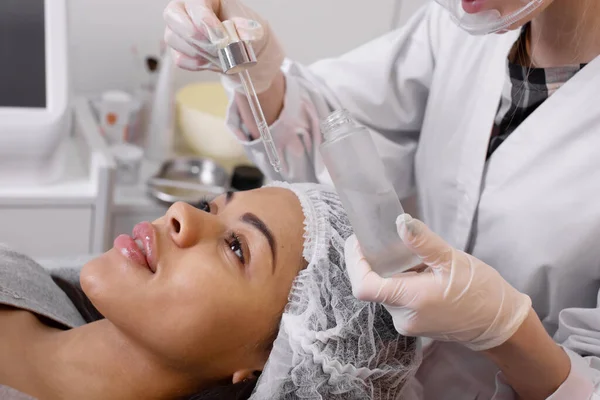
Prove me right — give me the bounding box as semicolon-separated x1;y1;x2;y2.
251;182;421;400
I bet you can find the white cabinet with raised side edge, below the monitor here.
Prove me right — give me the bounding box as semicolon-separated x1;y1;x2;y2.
0;99;115;259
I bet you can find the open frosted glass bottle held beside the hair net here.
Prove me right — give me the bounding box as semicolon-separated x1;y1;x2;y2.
319;110;420;277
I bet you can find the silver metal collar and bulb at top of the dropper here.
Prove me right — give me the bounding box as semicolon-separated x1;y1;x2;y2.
219;20;256;75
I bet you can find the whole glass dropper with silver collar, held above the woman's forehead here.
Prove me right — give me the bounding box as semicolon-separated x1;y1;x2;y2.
219;20;281;172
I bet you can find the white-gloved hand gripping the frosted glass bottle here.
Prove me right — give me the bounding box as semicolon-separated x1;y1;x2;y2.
344;214;531;351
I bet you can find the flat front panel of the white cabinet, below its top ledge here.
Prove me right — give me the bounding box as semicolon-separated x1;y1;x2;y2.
0;206;93;257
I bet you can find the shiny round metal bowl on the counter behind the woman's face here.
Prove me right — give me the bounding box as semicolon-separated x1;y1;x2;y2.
146;157;231;204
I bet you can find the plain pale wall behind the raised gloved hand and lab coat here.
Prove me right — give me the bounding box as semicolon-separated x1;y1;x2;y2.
69;0;428;93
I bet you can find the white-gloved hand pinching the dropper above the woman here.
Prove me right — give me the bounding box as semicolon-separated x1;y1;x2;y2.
163;0;284;93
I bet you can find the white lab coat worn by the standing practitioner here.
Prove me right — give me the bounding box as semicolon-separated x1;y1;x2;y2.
228;4;600;400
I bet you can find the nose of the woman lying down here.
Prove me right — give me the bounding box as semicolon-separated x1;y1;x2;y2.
166;202;210;248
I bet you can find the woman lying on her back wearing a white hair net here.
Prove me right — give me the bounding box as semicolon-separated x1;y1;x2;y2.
0;184;420;400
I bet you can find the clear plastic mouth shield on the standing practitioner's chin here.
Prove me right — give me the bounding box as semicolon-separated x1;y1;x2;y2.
435;0;544;35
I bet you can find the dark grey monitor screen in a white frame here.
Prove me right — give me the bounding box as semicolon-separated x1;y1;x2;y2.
0;0;46;108
